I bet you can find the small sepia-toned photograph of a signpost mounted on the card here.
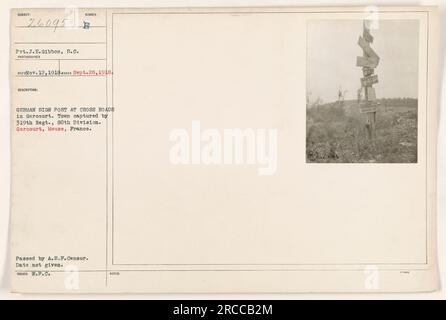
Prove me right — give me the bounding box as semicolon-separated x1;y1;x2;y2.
306;19;419;163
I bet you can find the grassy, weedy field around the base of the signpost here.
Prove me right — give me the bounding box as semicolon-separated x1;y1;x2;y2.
306;99;417;163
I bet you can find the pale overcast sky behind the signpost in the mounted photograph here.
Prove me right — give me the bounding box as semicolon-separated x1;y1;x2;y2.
307;20;419;102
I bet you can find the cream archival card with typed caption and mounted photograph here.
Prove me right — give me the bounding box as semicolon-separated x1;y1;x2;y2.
10;7;438;293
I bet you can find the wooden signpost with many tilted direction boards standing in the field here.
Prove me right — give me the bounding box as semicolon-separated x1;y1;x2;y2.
356;22;379;139
